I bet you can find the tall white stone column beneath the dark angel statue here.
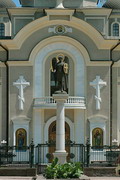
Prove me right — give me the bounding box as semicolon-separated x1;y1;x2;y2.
53;93;68;164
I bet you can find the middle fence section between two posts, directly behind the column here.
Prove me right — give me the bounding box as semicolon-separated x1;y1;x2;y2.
35;144;87;165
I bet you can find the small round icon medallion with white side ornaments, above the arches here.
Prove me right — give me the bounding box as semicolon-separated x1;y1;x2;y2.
48;25;72;35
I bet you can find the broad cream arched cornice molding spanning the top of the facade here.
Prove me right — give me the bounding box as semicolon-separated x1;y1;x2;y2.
0;16;119;50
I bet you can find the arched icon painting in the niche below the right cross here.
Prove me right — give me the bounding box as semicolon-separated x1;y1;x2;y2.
92;127;103;146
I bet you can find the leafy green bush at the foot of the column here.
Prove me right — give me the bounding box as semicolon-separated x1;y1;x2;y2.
43;158;83;179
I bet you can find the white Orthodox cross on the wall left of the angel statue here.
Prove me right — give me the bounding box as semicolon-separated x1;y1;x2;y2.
13;76;30;110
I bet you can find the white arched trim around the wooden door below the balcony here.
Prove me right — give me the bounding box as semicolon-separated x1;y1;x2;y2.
44;116;74;143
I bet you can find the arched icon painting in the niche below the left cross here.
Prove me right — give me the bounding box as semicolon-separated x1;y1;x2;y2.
16;128;27;147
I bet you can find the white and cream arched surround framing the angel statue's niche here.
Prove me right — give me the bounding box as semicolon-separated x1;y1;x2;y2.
29;36;90;98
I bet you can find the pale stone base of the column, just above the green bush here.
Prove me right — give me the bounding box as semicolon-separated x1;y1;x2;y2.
53;152;68;164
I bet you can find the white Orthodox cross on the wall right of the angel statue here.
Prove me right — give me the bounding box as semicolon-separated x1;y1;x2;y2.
90;76;107;110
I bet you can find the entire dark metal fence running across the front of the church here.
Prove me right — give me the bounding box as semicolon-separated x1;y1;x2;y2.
0;143;120;167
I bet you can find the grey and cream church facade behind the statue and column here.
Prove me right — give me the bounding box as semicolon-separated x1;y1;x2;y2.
0;0;120;149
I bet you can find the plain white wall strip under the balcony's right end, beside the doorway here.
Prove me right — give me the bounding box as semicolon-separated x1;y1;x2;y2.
74;109;85;144
